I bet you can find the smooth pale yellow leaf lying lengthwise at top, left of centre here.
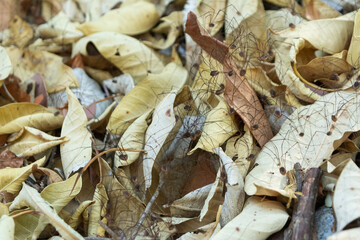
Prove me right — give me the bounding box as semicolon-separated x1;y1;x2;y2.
78;1;159;35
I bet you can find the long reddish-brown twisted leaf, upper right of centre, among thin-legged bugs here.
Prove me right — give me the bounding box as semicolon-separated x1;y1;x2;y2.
185;12;273;146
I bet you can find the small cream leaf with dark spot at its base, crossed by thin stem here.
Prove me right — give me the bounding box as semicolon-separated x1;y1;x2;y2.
114;111;150;167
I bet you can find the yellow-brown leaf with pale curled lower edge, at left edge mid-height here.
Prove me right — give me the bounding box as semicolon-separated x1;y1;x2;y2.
0;102;64;134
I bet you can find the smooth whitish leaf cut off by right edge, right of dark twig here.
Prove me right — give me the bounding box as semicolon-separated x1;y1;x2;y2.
333;161;360;232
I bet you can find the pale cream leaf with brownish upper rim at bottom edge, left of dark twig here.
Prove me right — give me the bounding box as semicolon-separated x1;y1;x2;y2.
212;197;289;240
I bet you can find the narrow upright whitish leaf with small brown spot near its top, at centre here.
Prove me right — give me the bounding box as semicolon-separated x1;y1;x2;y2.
143;91;176;190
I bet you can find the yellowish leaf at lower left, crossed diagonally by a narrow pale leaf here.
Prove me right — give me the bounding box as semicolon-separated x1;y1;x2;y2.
15;175;82;239
